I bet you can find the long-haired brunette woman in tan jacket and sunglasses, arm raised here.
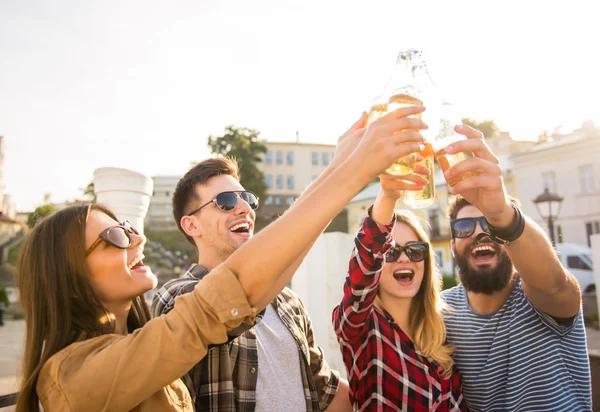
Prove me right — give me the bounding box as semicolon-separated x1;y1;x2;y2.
17;107;424;412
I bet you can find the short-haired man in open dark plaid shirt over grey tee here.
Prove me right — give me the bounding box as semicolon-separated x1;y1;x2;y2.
151;154;352;412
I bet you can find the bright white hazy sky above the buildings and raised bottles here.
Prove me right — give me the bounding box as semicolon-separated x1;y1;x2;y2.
0;0;600;211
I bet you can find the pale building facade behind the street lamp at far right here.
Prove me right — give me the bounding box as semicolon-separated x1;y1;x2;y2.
511;122;600;246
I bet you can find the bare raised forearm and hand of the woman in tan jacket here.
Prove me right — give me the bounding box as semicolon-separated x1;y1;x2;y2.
225;107;424;309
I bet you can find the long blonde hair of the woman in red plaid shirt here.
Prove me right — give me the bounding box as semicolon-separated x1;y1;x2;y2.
376;211;454;378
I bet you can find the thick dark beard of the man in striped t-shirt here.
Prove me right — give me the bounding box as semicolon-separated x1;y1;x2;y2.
456;241;514;295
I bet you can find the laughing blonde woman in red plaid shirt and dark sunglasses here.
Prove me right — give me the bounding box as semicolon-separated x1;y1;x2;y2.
333;175;467;411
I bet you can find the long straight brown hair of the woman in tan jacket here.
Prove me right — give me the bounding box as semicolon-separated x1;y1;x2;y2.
17;204;150;412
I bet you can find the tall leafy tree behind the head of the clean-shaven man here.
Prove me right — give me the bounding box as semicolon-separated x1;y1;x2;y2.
208;125;267;203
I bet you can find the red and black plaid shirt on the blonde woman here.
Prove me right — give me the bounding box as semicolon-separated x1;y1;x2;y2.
333;209;467;411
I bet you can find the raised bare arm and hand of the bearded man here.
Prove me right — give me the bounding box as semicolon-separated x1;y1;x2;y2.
446;126;581;318
